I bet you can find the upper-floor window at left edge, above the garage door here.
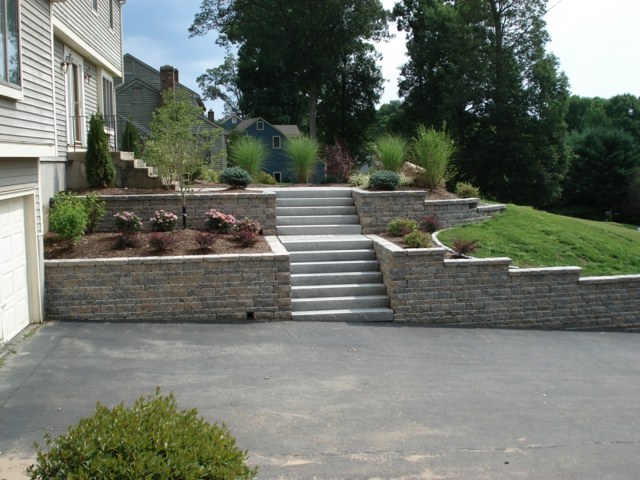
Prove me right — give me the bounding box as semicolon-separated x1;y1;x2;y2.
0;0;21;86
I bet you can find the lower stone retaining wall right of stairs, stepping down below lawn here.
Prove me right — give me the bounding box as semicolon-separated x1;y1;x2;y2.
371;235;640;330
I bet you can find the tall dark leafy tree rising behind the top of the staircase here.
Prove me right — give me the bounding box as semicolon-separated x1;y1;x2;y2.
189;0;387;137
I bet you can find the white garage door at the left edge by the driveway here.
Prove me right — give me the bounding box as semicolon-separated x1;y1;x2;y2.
0;198;29;341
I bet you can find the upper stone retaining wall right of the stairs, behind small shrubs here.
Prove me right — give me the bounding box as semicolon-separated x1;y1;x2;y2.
353;189;506;234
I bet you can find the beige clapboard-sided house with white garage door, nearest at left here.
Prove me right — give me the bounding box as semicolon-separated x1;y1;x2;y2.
0;0;124;342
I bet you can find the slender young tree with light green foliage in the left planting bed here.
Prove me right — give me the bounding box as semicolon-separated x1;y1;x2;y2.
144;90;220;228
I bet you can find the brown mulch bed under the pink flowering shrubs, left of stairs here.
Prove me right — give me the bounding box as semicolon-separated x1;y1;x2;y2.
44;229;271;260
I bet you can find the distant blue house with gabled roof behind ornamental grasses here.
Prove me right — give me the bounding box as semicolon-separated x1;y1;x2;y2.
231;116;301;182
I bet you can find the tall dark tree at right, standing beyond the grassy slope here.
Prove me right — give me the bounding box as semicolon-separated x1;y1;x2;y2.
394;0;568;205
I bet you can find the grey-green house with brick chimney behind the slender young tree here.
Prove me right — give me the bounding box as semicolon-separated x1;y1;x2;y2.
116;53;226;169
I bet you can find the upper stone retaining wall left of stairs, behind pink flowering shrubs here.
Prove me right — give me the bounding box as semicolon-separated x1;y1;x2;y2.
93;191;276;235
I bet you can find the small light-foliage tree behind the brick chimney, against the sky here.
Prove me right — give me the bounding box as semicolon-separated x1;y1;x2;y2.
196;52;242;115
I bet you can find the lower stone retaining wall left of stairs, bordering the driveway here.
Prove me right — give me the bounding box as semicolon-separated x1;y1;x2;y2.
44;237;291;322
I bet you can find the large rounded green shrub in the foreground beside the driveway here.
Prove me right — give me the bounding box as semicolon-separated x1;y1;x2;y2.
27;389;257;480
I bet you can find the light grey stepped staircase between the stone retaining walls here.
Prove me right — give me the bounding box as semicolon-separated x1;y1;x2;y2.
276;187;393;322
